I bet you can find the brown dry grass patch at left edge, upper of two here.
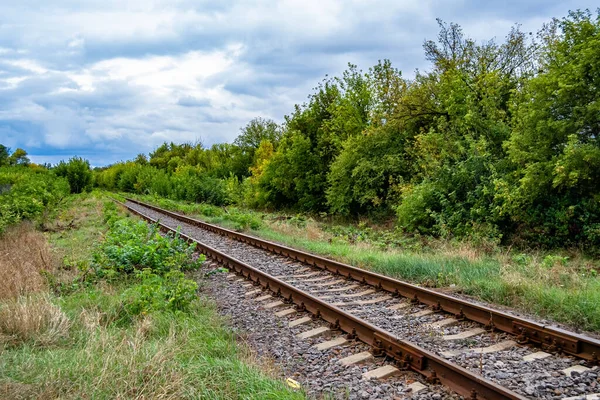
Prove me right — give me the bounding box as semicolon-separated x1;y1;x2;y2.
0;223;55;300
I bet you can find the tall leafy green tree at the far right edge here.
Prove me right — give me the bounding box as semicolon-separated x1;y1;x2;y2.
501;11;600;245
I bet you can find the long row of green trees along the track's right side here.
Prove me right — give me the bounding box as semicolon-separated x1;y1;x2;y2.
7;11;600;250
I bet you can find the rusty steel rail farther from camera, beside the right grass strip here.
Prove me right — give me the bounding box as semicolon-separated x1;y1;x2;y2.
127;198;600;364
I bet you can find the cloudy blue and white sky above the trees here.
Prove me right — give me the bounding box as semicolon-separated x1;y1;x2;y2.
0;0;597;165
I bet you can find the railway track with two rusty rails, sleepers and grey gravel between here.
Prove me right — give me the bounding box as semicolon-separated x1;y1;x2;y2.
118;199;600;399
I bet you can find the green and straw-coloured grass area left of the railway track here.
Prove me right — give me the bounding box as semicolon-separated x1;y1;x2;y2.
0;192;304;399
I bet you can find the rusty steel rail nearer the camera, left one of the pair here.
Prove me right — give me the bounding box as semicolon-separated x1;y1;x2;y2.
115;200;526;400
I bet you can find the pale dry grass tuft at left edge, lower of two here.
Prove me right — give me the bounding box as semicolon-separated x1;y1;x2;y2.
0;294;71;346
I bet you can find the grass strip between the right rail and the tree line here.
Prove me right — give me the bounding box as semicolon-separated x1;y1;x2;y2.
124;192;600;332
